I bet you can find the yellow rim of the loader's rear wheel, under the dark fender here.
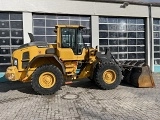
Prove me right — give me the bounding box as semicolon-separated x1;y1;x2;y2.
39;72;56;88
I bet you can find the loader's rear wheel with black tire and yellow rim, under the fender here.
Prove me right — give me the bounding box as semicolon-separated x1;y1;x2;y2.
31;65;64;95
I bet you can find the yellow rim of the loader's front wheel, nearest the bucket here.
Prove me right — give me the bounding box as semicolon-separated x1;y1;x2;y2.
103;69;116;84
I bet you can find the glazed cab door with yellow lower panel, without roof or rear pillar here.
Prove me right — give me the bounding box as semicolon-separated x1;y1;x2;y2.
58;28;85;61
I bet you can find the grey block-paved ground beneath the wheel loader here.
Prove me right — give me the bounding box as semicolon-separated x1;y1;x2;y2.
0;73;160;120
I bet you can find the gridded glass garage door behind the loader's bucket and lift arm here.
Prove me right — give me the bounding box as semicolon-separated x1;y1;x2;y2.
99;17;145;61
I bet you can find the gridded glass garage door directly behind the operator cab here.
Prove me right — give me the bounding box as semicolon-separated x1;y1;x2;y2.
33;14;91;44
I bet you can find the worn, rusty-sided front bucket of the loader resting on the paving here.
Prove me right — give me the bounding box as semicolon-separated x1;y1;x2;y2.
124;65;155;88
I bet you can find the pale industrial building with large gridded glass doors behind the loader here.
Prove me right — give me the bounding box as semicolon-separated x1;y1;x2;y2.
0;0;160;80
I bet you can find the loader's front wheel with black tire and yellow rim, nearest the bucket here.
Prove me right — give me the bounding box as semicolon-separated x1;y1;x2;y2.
94;62;122;90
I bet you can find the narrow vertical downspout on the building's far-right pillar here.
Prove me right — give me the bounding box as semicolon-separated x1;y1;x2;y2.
148;4;154;72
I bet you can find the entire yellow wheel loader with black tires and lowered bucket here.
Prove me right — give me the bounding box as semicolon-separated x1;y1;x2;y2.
5;25;154;95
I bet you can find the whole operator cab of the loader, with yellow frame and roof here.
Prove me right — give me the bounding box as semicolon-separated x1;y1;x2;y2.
55;25;86;61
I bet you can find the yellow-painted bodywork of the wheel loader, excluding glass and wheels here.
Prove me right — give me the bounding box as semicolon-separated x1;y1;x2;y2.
6;25;97;82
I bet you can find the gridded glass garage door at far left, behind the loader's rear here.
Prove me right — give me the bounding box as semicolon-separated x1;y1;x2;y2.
0;12;23;72
